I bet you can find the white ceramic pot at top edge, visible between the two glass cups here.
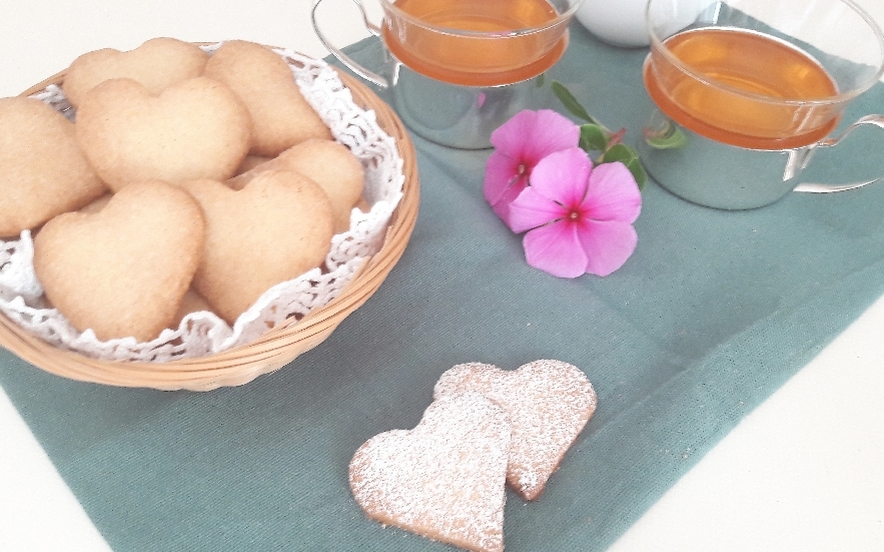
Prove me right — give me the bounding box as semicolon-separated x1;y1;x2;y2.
576;0;650;48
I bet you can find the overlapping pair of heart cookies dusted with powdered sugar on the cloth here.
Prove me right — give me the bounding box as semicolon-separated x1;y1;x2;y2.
349;360;596;552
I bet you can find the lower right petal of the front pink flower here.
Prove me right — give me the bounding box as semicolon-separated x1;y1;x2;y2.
576;216;638;276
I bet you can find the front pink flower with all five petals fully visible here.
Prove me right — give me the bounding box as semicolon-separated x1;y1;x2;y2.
509;147;642;278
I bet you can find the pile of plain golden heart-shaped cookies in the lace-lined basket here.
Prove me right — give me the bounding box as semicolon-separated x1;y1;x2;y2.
0;38;364;342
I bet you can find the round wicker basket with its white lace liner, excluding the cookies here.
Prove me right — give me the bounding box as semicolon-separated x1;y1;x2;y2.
0;46;410;382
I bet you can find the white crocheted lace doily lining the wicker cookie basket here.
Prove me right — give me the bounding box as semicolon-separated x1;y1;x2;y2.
0;43;405;362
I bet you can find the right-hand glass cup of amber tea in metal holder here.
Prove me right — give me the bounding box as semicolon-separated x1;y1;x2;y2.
640;0;884;209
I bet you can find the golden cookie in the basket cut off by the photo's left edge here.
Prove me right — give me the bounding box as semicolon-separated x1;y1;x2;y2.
0;97;106;236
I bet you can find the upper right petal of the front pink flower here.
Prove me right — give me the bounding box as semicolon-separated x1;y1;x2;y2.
584;162;642;223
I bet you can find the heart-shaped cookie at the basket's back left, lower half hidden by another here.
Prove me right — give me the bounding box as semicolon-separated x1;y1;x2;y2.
62;37;209;107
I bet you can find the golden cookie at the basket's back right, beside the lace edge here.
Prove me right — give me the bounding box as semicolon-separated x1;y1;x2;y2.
204;40;332;157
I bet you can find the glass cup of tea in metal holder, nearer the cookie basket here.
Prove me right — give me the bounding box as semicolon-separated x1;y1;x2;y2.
313;0;583;149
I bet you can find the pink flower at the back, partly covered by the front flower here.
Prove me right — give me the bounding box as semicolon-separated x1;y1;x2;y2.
484;109;580;227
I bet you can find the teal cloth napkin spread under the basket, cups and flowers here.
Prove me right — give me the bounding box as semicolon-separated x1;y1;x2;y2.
0;25;884;552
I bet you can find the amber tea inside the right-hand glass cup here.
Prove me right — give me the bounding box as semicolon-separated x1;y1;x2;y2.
644;27;840;149
